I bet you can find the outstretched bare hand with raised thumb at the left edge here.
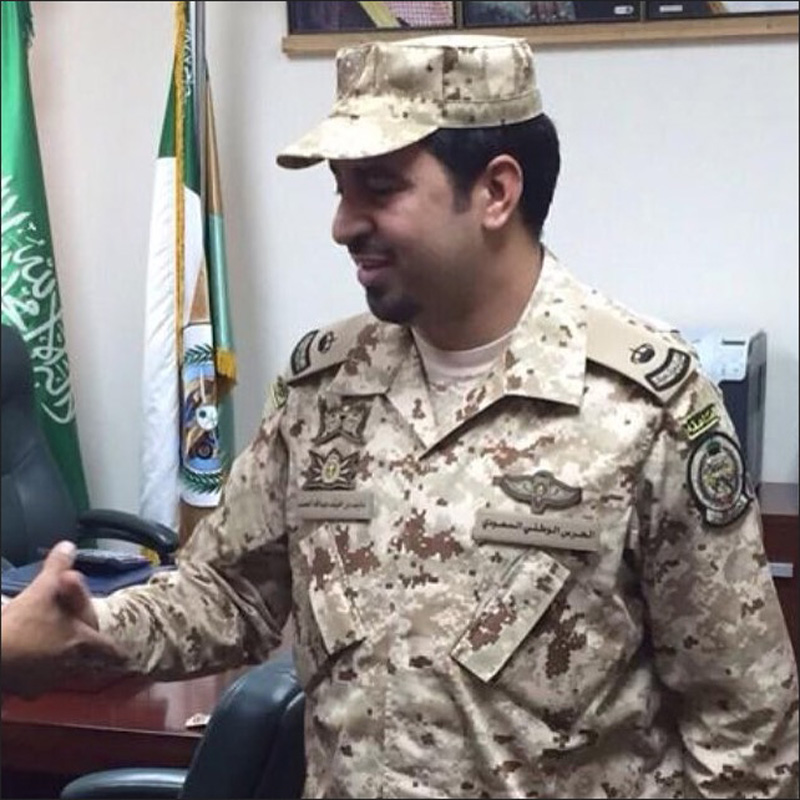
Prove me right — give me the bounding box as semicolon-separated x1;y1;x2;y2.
0;541;125;697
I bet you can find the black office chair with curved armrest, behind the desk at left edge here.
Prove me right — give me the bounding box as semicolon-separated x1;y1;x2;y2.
0;325;178;570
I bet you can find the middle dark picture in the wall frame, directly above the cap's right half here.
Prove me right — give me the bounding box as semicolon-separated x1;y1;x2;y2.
461;0;642;28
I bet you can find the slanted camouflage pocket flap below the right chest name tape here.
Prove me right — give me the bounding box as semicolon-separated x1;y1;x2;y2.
450;550;570;682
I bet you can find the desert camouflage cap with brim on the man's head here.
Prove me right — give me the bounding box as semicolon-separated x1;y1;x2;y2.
277;35;542;169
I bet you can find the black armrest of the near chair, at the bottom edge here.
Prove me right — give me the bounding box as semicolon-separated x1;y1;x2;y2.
60;767;186;800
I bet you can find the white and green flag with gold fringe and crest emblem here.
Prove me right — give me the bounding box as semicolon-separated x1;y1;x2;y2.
140;2;236;541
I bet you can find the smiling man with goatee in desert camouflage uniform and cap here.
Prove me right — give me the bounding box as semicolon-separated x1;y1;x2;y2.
15;36;798;797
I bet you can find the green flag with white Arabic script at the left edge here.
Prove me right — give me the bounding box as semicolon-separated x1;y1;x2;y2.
2;0;89;511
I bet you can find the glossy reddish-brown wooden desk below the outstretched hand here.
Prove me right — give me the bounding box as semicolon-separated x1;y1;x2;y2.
2;670;243;797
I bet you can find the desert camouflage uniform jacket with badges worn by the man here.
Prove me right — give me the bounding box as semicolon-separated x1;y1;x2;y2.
98;254;798;798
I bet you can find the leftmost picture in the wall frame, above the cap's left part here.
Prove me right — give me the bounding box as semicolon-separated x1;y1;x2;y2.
286;0;456;34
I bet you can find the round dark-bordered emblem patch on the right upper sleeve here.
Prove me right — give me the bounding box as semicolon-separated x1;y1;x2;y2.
687;434;753;528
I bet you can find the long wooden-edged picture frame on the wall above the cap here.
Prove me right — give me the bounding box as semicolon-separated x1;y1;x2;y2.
282;0;800;57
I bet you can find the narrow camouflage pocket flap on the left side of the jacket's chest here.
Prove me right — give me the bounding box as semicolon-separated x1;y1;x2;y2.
298;525;366;656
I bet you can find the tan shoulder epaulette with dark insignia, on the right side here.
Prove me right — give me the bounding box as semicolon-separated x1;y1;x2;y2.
586;307;697;405
